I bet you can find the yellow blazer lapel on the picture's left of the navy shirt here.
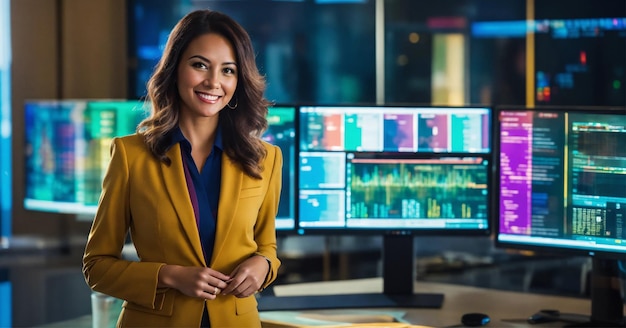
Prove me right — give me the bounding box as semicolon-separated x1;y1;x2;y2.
161;144;206;266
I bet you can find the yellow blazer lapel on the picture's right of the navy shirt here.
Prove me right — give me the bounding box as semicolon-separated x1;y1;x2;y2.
211;154;243;265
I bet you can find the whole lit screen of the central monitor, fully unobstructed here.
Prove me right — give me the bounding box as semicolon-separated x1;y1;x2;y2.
298;106;492;234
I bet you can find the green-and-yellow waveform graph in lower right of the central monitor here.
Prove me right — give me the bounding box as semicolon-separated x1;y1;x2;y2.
347;154;489;227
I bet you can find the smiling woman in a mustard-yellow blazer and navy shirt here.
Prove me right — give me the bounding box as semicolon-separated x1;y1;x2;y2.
83;10;282;327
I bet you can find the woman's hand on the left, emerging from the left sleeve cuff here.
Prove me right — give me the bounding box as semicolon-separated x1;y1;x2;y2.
159;265;230;300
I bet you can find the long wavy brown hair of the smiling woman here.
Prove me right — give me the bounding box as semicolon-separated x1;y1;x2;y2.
137;10;271;178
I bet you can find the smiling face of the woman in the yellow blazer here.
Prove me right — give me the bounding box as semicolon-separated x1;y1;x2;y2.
177;33;238;118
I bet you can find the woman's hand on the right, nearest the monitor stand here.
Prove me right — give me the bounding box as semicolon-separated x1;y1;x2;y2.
222;255;270;297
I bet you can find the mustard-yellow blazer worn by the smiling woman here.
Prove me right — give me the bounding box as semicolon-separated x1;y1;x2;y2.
83;134;283;328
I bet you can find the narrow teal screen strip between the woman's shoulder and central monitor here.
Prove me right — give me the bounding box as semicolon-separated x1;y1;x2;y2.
263;105;297;232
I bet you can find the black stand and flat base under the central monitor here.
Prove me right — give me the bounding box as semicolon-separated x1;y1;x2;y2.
258;234;444;311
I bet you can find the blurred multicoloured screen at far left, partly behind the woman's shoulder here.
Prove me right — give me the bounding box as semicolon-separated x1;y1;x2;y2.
24;100;145;215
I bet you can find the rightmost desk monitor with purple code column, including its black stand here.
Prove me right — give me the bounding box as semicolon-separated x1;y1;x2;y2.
494;107;626;326
